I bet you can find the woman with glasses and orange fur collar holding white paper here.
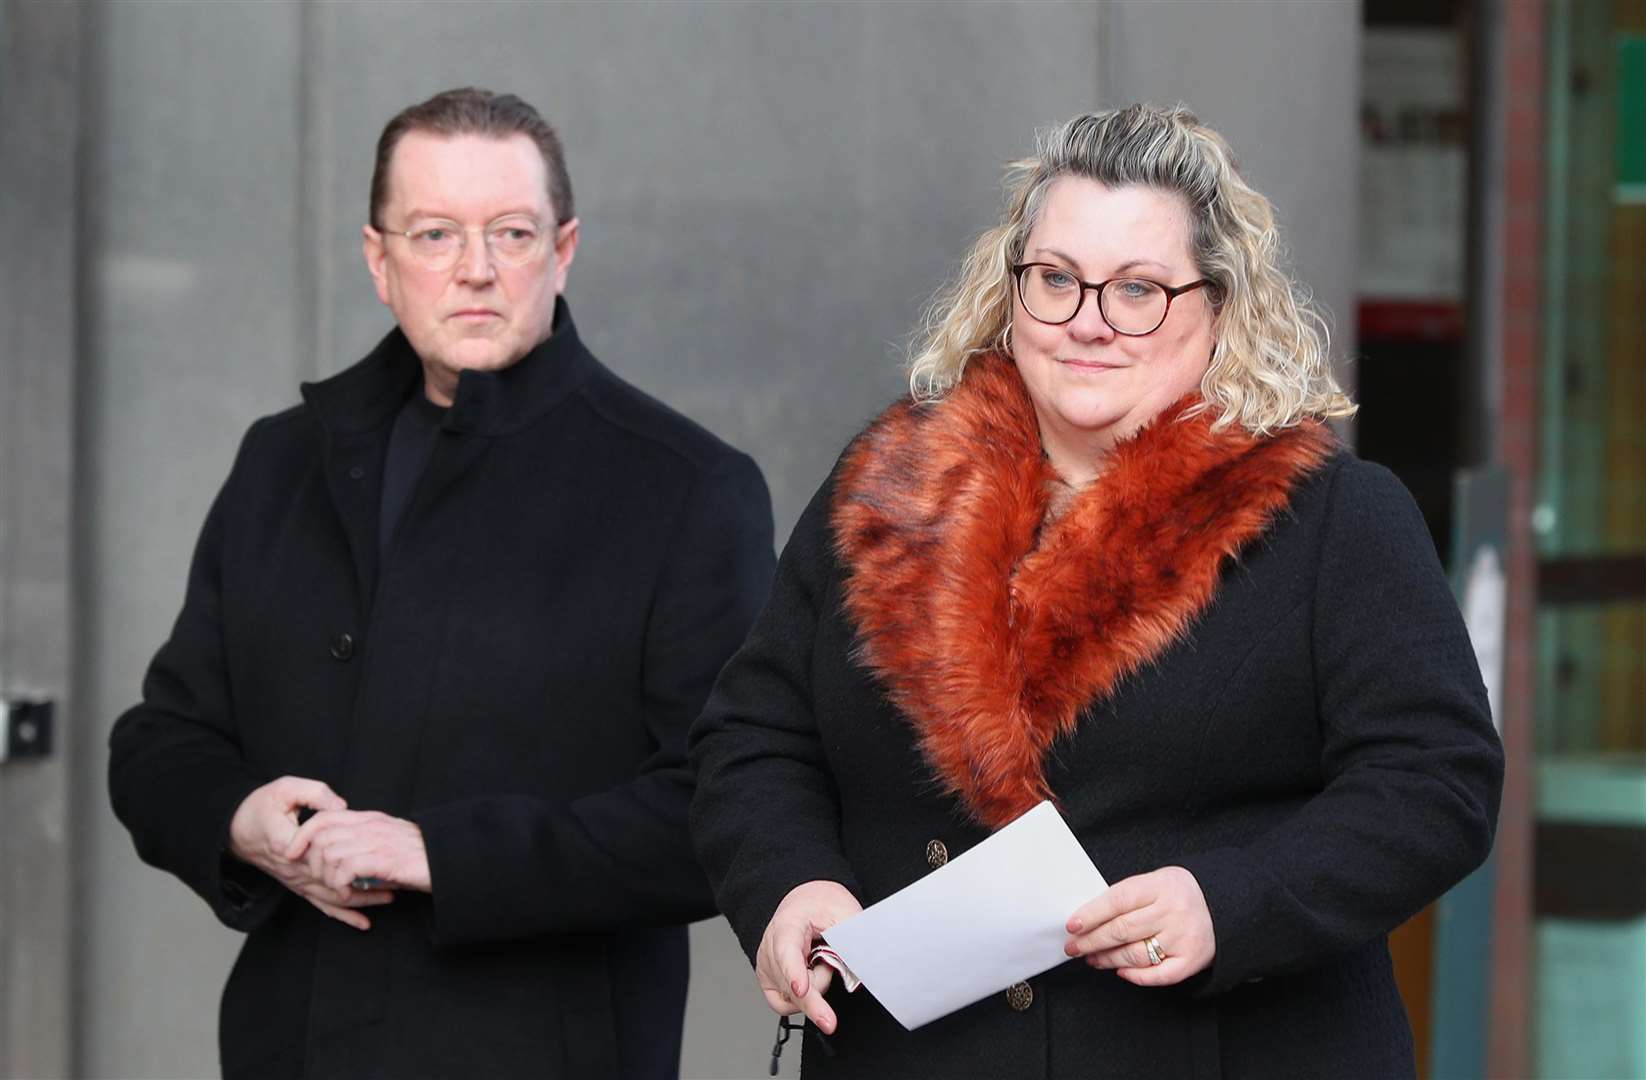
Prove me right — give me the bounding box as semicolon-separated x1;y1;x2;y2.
691;105;1503;1077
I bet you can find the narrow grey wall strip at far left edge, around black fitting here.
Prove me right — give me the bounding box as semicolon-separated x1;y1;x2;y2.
0;0;82;1077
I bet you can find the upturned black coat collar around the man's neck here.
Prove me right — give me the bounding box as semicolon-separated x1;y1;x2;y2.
303;296;597;436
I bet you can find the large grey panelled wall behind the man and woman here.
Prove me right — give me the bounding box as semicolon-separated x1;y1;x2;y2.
77;0;1358;1077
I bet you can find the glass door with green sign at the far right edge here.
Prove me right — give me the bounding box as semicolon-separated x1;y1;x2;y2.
1532;0;1646;1078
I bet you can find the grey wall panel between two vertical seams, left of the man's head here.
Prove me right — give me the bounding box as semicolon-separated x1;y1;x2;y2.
77;3;313;1077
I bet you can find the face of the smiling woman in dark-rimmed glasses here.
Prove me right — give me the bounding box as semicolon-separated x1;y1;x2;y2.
1012;176;1211;461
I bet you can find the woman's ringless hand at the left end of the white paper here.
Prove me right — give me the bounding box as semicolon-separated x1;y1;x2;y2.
754;881;863;1036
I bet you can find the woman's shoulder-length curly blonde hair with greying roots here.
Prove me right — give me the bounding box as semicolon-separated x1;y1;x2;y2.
909;105;1356;435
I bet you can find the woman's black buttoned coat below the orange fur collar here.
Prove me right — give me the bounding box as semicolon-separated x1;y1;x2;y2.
691;365;1503;1080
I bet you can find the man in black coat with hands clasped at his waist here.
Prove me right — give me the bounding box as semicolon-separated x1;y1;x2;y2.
109;89;772;1080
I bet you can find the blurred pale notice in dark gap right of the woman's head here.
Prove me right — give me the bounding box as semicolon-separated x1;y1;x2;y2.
1360;28;1468;305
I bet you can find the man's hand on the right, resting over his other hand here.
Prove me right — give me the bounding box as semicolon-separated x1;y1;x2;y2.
281;807;431;892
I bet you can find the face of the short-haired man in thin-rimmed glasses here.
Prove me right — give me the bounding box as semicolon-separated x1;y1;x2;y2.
365;132;578;403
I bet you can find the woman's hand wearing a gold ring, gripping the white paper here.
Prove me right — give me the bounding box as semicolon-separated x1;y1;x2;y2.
1063;866;1218;986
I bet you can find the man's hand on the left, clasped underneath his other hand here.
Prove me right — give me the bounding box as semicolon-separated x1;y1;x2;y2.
229;777;395;930
